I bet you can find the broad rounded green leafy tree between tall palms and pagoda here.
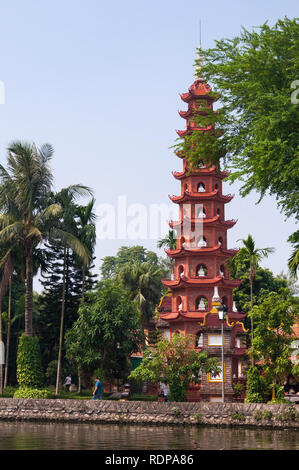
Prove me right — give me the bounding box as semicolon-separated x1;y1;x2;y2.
66;280;144;380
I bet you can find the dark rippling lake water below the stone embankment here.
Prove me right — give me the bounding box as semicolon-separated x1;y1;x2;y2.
0;421;299;450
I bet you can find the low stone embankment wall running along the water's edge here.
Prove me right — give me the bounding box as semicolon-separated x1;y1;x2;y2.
0;398;299;430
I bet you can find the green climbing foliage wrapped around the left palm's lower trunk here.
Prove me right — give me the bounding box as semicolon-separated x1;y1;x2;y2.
17;333;44;388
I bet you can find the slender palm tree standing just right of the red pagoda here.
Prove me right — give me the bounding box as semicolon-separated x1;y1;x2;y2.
238;234;275;365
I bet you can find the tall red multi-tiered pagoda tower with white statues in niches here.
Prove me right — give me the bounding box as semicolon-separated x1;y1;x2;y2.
158;69;246;401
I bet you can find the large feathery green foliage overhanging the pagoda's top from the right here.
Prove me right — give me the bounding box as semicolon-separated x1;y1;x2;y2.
196;17;299;222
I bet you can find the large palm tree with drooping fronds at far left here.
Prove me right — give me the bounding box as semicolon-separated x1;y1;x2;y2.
0;141;88;336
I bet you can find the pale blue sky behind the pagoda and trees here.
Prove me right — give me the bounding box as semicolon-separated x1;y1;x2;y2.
0;0;298;284
